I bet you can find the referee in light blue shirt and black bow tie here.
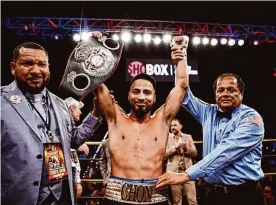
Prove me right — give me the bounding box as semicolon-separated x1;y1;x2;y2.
157;73;264;205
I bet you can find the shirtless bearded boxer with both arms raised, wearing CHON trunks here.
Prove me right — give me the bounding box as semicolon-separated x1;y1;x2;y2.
94;33;188;205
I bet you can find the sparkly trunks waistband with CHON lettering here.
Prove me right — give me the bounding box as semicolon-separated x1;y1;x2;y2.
105;176;168;204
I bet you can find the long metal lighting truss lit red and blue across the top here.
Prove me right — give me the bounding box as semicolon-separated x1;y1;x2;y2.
5;17;276;42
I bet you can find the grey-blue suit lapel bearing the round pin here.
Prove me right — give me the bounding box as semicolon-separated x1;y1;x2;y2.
3;82;41;140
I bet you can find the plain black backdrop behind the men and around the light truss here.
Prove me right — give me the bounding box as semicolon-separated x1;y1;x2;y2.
1;2;276;143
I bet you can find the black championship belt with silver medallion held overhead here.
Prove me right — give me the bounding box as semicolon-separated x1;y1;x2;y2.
60;35;123;100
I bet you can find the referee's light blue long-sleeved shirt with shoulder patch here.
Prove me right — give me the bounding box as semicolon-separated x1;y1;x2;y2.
182;89;264;185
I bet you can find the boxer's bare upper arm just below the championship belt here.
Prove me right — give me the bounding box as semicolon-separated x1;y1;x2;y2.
95;84;116;122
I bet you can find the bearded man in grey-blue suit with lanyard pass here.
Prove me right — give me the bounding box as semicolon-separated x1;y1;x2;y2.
1;42;101;205
